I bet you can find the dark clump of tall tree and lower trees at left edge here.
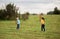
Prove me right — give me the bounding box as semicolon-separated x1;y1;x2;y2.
0;3;18;20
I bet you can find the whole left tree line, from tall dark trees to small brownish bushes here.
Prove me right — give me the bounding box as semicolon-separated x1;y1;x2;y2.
0;3;29;20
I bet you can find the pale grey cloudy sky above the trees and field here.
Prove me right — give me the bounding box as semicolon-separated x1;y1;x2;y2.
0;0;60;14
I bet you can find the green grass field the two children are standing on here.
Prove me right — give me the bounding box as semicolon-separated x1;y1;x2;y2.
0;15;60;39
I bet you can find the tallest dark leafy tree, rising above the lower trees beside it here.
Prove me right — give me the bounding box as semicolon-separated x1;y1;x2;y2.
6;3;18;19
